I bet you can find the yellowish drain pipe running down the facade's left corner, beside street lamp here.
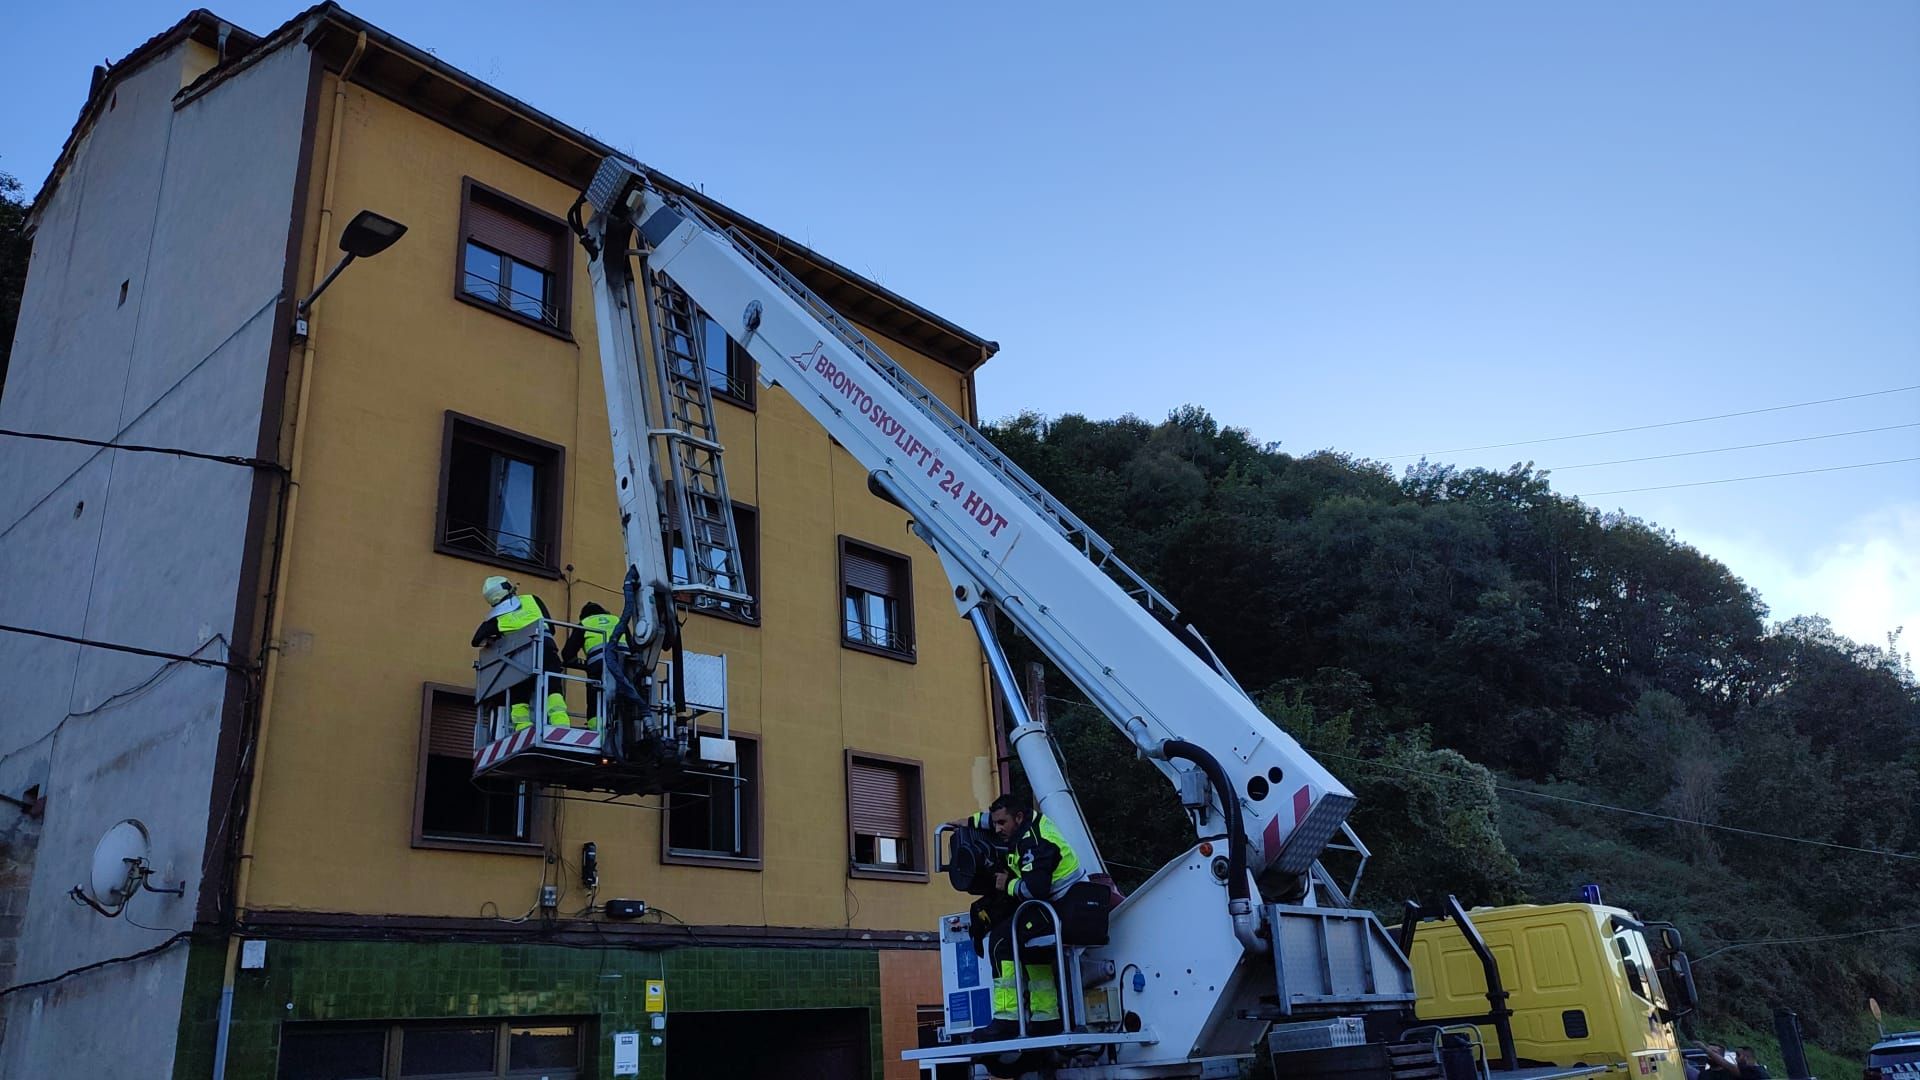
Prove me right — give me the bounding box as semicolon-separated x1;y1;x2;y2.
213;31;367;1080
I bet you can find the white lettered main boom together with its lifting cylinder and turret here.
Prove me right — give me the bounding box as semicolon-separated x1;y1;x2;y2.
586;158;1371;1074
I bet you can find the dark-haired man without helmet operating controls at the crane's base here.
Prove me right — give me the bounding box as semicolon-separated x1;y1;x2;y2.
950;792;1087;1042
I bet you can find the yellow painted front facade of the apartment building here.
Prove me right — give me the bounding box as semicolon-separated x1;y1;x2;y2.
244;73;996;930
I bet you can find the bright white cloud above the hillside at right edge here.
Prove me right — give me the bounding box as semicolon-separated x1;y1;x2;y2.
1680;502;1920;651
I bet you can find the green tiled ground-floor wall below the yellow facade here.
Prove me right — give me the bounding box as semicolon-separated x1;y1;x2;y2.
173;940;881;1080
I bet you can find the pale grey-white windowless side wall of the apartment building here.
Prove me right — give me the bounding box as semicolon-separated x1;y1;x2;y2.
0;46;309;1076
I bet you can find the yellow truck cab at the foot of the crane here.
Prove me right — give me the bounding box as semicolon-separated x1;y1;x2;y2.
1407;903;1693;1080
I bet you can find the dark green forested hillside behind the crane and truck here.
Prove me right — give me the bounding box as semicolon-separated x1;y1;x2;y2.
987;407;1920;1078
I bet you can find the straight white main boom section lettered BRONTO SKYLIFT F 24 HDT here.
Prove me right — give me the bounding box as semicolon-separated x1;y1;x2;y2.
589;160;1354;874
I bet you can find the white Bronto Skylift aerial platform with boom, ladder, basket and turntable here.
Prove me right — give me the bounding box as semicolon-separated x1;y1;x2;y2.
474;158;1704;1080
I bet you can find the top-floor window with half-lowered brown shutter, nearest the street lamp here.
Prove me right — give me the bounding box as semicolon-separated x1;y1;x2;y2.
455;179;572;336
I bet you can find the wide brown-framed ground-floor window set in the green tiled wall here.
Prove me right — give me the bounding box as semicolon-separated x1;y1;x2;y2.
278;1019;588;1080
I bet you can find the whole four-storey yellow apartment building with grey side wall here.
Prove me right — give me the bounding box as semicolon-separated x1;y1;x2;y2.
0;4;1004;1080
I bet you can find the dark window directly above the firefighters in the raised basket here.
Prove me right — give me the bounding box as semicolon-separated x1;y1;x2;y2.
434;411;566;577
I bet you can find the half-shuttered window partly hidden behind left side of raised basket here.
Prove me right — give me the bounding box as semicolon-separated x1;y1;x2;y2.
413;682;541;855
